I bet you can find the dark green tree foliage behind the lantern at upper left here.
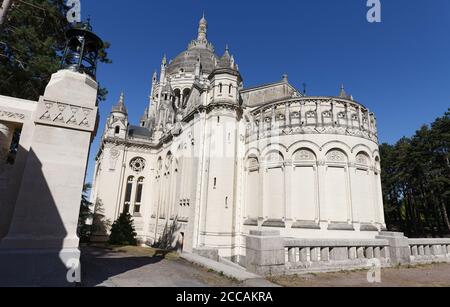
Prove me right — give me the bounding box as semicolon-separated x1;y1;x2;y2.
0;0;111;100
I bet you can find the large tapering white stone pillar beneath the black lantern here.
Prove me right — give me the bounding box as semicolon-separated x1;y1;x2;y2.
0;70;98;286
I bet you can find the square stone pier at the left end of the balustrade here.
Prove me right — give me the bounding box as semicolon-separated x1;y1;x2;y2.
246;231;286;275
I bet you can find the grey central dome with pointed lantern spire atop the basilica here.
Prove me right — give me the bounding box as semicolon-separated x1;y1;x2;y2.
167;16;219;75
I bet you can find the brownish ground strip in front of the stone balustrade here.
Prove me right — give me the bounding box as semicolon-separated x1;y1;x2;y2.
270;264;450;287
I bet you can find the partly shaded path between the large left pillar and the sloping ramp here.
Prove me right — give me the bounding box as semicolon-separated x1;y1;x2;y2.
81;247;241;287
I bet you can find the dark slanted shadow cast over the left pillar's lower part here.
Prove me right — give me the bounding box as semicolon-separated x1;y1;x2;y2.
0;146;74;287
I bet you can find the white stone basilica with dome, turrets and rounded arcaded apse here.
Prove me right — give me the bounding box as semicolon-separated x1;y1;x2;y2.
92;17;385;259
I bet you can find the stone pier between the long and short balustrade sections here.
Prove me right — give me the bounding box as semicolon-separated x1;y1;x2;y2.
376;232;411;265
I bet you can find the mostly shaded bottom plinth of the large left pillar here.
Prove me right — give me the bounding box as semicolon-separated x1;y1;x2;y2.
0;248;81;287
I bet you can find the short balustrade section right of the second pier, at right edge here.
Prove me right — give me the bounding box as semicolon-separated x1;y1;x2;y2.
409;239;450;263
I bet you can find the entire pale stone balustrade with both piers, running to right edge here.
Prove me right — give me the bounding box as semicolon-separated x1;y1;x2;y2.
245;231;450;276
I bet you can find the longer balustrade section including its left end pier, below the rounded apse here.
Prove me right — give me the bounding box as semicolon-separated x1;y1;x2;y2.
246;231;391;275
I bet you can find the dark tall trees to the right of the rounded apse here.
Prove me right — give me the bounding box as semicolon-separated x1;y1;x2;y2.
380;110;450;237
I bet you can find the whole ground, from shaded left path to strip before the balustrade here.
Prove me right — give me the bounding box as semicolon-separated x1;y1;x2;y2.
81;247;450;287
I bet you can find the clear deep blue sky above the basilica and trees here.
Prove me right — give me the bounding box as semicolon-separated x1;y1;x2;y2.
81;0;450;182
